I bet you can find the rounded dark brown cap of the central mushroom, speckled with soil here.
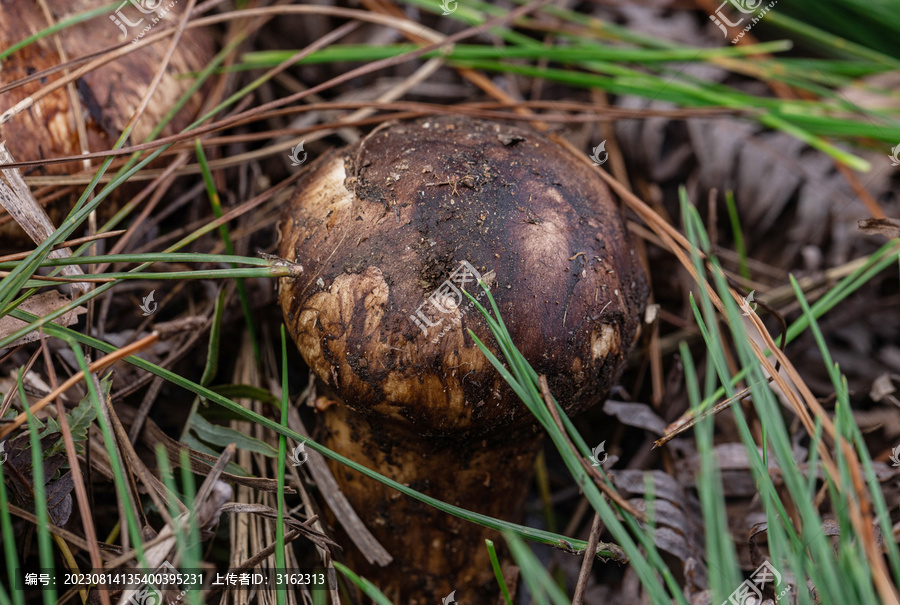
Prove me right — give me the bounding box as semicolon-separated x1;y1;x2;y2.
280;117;648;436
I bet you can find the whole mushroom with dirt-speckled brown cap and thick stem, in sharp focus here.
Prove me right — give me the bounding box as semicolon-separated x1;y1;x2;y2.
279;117;648;604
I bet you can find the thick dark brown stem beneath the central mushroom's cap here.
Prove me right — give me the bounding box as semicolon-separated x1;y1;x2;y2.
322;394;542;605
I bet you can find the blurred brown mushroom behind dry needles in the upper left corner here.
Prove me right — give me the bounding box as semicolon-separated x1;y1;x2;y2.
0;0;213;248
